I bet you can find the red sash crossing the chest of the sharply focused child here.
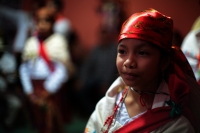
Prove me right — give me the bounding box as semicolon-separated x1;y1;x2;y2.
114;106;177;133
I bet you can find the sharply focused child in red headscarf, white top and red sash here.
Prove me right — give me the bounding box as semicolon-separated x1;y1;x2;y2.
85;8;200;133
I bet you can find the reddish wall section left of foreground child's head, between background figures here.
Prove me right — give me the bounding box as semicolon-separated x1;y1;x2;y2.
63;0;100;50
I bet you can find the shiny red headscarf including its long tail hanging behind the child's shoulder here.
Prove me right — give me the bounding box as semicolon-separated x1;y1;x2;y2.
118;8;196;132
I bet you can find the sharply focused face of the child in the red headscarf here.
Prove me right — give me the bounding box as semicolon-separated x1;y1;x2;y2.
116;39;161;91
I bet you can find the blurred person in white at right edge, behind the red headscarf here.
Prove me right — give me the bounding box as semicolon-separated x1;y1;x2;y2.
181;17;200;84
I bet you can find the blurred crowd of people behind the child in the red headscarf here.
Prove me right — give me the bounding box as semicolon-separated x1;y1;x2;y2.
0;0;200;133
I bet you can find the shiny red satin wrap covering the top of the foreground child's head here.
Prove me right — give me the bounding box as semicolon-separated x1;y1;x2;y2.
118;8;173;51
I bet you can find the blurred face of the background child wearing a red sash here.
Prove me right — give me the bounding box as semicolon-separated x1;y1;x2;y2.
36;8;53;37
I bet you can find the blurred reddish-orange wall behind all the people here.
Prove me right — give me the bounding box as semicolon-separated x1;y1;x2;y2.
64;0;200;50
